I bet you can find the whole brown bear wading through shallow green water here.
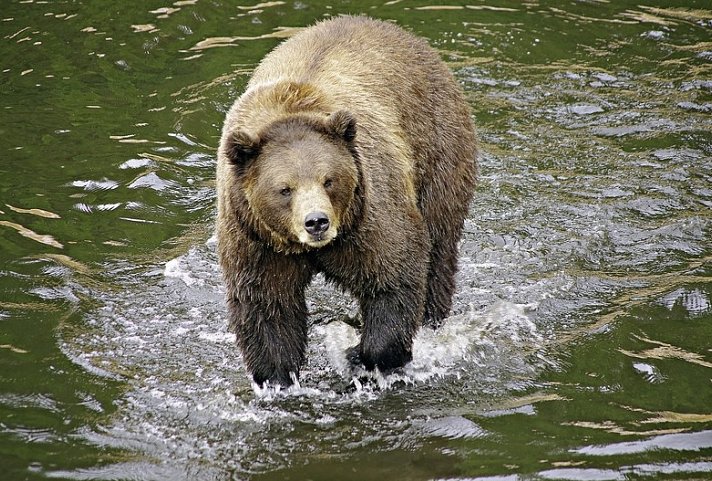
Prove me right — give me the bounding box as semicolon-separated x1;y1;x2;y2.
216;16;477;386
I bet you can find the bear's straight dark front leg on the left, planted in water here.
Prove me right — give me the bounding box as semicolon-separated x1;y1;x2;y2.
228;251;310;387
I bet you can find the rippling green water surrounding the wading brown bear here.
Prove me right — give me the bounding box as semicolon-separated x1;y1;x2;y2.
0;0;712;481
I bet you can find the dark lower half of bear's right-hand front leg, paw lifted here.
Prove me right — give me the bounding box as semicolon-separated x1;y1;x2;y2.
357;290;424;374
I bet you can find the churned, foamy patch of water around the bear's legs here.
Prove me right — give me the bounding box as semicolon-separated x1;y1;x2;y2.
55;236;547;472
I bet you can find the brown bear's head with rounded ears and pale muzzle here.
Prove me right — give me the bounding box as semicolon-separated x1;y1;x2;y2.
223;111;360;252
